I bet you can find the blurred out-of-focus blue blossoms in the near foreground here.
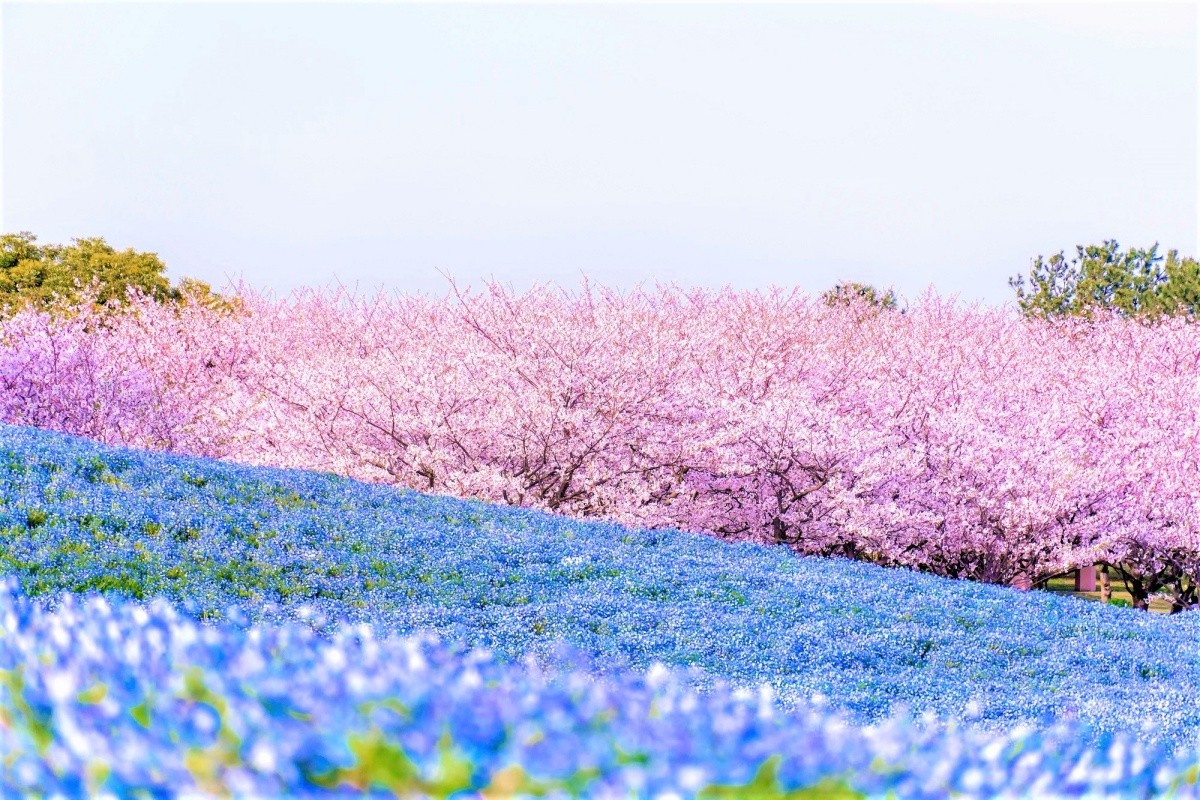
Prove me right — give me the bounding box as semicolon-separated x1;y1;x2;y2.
0;583;1198;799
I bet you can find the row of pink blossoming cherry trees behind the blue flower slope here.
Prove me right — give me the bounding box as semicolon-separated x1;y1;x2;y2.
0;285;1200;609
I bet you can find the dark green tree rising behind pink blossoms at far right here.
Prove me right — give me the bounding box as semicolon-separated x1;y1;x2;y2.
1008;240;1200;318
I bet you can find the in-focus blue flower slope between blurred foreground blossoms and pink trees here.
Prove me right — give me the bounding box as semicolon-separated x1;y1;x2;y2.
0;426;1200;796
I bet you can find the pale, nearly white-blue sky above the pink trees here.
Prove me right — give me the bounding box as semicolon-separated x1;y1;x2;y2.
0;2;1198;303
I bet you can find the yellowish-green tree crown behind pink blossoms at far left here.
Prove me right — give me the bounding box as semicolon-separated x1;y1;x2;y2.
0;231;218;311
